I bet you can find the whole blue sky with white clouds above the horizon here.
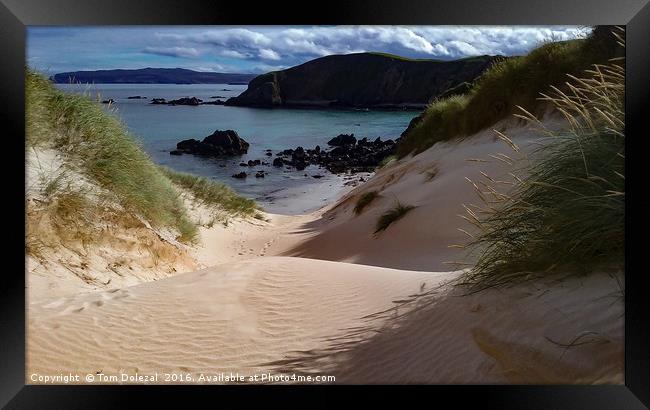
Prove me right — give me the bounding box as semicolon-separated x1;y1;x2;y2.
27;26;588;74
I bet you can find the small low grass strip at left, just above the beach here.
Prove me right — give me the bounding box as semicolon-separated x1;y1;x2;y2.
161;167;258;216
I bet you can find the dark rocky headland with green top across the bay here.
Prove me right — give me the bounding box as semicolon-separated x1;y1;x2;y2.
226;53;499;108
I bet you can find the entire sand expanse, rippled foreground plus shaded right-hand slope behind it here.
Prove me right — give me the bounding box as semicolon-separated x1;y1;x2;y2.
27;116;623;383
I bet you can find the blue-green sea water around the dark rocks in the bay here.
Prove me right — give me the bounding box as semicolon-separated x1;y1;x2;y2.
57;84;418;214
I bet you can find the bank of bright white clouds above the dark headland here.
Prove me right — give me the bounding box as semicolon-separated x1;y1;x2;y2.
152;26;581;62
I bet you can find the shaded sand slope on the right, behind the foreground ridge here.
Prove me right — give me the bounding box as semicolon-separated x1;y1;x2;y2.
282;119;561;271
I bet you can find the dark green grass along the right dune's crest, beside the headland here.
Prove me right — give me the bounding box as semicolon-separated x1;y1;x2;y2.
397;26;623;158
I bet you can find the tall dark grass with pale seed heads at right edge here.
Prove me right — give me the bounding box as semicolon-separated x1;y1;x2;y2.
460;37;625;288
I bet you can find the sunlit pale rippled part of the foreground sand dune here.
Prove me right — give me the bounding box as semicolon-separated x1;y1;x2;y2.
28;257;438;382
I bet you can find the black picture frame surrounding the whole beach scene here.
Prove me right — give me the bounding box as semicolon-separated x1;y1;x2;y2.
0;0;650;409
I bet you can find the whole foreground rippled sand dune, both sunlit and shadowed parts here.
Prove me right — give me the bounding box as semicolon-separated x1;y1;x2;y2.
27;257;623;383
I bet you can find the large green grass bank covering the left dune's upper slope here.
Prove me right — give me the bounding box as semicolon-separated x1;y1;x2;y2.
25;70;196;241
